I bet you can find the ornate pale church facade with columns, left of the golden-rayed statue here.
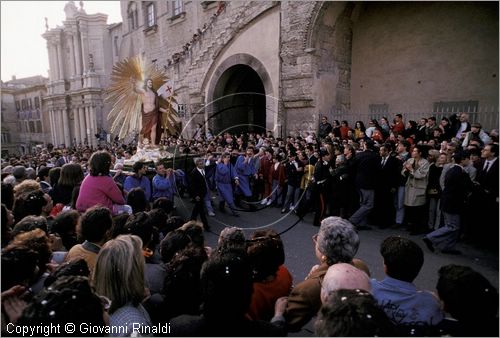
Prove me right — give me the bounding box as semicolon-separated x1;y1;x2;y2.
43;1;119;146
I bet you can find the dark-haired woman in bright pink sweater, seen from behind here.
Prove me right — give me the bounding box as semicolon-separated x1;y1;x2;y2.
76;151;125;214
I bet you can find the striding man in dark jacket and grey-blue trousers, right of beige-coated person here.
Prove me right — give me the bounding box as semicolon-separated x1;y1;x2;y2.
423;151;472;254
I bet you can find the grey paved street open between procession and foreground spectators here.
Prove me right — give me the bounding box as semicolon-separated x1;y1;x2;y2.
176;193;498;337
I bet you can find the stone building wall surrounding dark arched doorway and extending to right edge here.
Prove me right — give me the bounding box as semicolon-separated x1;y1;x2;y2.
114;1;498;135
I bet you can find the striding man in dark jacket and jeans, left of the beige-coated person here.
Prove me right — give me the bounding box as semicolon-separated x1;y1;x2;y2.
349;140;380;230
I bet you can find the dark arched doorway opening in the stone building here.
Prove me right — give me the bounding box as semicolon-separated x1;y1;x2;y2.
208;64;266;134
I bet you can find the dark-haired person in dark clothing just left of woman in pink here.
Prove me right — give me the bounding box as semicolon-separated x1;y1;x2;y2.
49;163;83;205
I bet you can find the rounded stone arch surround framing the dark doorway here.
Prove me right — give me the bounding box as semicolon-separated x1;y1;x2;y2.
205;53;277;135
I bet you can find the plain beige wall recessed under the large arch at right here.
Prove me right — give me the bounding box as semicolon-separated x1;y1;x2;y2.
351;2;499;115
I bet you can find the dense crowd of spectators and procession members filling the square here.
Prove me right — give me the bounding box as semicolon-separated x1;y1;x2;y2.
1;113;499;336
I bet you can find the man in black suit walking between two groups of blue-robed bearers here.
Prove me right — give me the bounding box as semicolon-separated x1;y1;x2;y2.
189;158;210;230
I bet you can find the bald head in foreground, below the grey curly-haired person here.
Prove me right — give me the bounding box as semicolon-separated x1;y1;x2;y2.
321;263;372;302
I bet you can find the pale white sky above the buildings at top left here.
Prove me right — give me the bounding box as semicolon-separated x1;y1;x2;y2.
0;0;122;81
